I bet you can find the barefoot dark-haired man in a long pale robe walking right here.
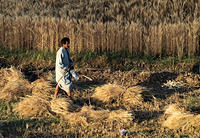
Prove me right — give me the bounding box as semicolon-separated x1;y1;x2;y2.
54;37;73;98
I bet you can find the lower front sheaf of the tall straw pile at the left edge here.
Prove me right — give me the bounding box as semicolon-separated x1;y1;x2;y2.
0;79;32;101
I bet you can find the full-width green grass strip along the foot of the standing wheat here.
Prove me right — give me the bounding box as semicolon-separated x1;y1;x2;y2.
0;46;200;71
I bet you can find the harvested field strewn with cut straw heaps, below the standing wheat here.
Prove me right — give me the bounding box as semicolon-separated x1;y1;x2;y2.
0;49;200;137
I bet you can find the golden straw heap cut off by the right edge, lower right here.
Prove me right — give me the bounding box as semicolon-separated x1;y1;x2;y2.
163;104;200;130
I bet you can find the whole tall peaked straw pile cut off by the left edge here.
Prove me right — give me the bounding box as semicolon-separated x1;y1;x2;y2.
0;67;32;101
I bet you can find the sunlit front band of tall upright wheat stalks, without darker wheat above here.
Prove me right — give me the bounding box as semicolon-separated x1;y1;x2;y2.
0;16;200;59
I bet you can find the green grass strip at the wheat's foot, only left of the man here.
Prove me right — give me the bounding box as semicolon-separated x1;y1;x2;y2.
0;46;55;68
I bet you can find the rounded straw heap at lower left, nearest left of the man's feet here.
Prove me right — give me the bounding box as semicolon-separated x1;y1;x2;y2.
14;95;51;118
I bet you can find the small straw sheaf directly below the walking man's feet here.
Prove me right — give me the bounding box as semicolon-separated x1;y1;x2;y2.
51;98;79;115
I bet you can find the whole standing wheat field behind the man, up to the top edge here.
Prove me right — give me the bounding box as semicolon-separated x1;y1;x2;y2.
0;0;200;59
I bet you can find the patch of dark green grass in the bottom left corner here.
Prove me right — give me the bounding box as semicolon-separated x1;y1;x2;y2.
0;101;60;137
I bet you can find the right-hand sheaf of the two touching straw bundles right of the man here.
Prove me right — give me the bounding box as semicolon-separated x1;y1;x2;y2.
123;86;147;105
